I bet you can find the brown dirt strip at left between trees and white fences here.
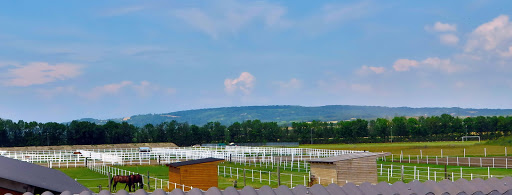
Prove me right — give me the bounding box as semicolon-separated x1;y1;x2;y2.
0;143;178;151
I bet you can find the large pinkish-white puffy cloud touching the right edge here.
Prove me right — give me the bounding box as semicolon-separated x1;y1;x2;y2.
465;15;512;52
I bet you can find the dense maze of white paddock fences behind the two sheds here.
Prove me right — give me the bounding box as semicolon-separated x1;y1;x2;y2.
0;146;362;169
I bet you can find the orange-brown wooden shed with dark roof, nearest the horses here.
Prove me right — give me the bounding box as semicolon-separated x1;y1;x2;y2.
167;158;224;191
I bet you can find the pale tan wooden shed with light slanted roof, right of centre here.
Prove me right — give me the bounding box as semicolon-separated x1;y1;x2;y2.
309;152;387;185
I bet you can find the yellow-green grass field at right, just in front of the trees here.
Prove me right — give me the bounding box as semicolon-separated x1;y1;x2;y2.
300;141;509;156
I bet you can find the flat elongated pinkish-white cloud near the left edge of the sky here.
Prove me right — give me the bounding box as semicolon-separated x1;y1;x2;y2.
5;62;82;87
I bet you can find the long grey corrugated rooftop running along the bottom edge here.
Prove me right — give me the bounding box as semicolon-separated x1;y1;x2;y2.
9;177;512;195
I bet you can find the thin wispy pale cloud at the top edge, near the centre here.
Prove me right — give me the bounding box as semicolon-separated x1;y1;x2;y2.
173;1;289;39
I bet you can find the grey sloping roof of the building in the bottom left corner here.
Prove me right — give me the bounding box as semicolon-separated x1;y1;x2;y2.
0;156;89;194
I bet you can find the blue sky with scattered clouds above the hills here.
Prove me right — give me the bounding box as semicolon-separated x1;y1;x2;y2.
0;0;512;122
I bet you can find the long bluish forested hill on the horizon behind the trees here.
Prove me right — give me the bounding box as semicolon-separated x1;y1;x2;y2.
73;105;512;126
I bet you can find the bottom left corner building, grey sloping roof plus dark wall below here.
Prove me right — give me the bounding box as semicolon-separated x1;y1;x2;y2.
0;156;90;195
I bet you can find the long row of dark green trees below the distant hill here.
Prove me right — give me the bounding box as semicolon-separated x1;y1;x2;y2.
0;114;512;147
